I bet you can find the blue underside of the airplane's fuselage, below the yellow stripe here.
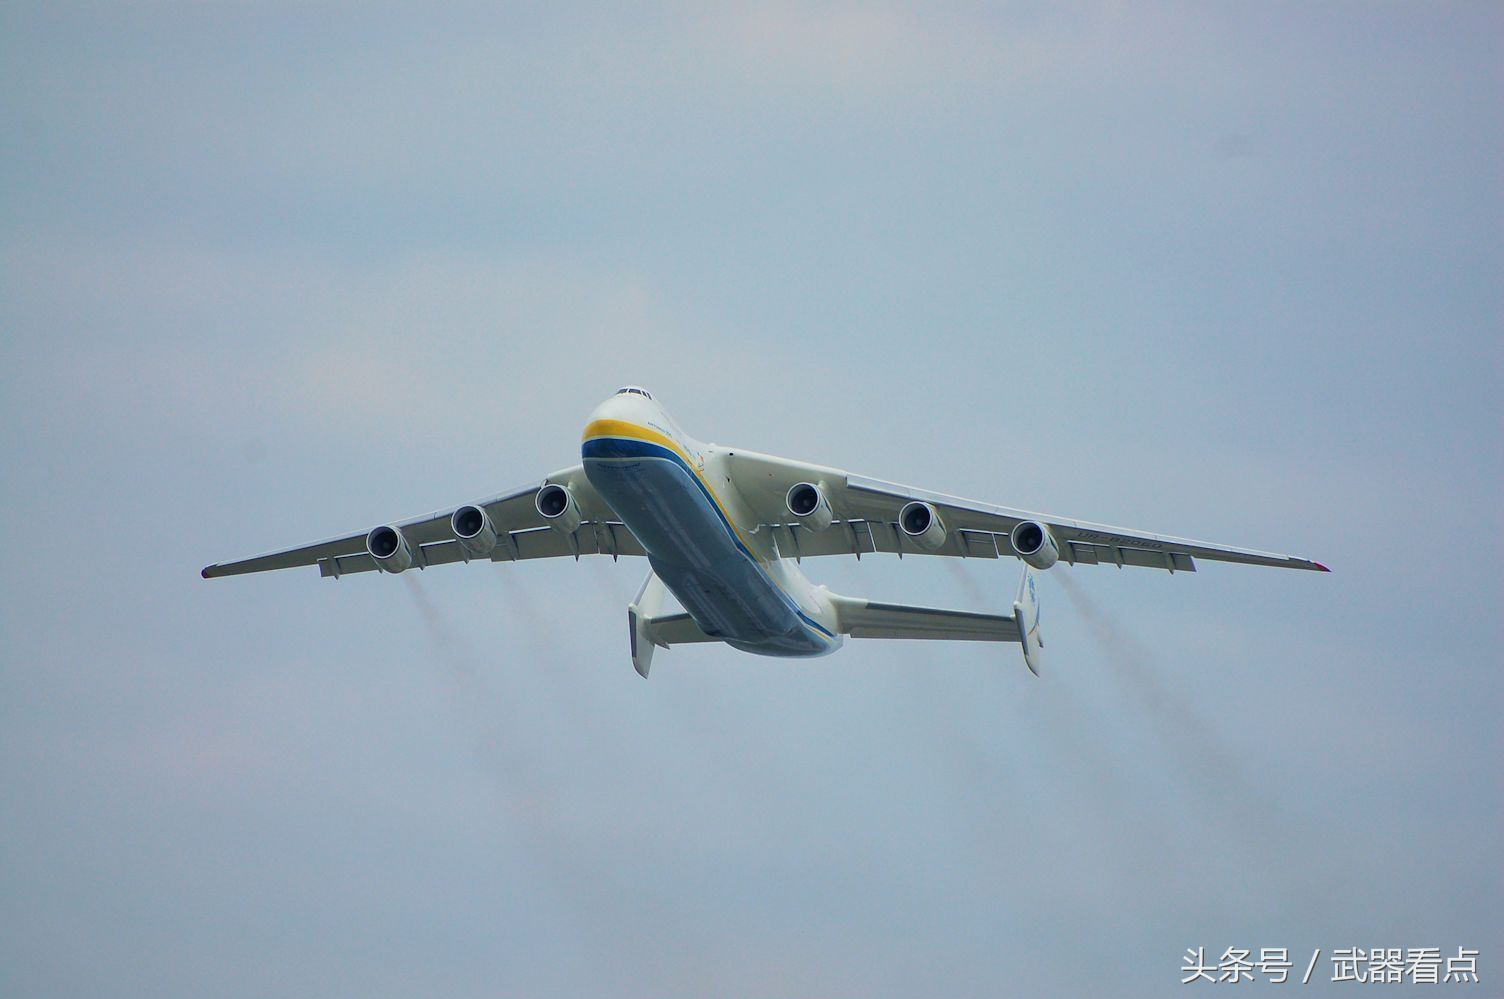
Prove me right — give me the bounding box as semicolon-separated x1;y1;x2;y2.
582;438;830;656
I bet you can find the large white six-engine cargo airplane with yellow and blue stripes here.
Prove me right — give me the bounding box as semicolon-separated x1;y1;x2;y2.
202;385;1331;679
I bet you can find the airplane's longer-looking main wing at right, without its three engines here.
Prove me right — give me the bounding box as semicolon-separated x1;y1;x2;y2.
728;448;1330;572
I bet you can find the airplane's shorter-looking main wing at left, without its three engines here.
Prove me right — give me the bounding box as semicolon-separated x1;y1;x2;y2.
202;465;642;579
